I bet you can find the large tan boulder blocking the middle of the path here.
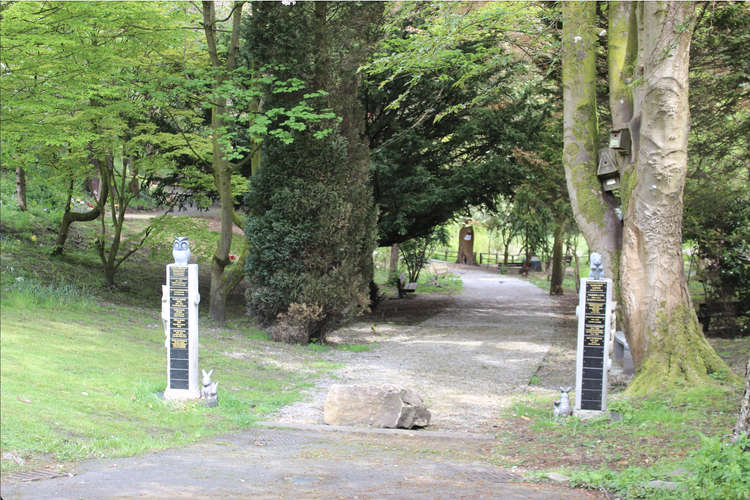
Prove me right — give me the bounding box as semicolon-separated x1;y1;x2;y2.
323;384;430;429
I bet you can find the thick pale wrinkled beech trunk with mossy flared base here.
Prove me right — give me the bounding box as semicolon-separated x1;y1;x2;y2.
621;2;728;394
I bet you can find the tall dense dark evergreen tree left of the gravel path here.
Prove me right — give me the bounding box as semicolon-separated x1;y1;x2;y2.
245;2;382;341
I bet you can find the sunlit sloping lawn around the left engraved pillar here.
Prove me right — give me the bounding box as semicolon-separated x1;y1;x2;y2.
0;280;337;473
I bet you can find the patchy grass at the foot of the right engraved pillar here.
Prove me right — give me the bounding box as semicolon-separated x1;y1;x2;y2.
492;385;750;499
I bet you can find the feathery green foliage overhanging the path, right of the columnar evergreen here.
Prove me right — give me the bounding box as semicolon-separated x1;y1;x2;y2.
363;2;550;246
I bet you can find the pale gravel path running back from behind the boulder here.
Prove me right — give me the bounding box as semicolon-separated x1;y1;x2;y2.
271;268;575;433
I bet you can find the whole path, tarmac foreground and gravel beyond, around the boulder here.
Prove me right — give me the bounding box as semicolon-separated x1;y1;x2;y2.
2;269;599;500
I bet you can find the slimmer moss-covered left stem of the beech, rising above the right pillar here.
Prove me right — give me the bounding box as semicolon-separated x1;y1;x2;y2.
562;2;621;278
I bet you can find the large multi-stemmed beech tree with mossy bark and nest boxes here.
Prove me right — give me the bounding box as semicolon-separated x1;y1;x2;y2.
563;2;728;393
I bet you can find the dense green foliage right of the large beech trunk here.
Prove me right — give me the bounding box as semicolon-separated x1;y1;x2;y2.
683;2;750;333
